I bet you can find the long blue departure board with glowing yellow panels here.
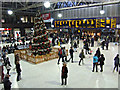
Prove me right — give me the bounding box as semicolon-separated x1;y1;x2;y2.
53;17;118;29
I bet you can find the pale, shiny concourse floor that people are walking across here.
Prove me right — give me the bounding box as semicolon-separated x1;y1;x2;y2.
0;41;118;89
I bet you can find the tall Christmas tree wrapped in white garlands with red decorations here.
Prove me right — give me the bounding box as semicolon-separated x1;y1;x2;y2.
32;12;52;56
